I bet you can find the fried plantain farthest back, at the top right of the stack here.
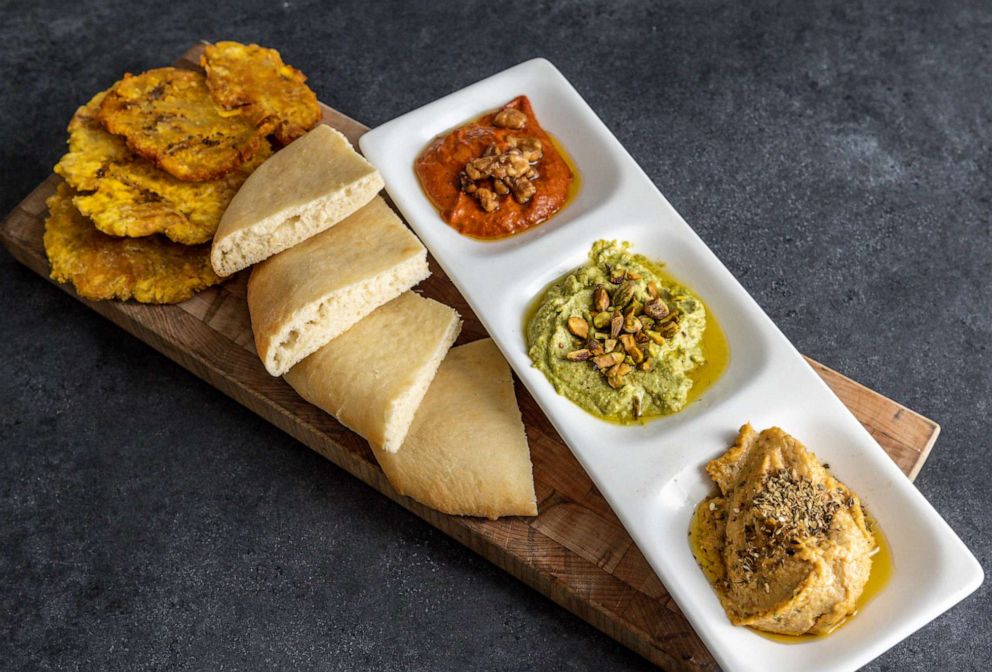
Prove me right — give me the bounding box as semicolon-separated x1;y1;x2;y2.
200;42;321;145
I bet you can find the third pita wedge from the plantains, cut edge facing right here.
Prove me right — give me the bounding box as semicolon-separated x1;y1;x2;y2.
285;292;461;453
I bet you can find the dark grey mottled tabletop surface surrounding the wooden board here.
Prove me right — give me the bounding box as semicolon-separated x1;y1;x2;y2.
0;0;992;670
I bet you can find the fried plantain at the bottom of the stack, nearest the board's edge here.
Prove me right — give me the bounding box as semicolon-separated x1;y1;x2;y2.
44;183;221;303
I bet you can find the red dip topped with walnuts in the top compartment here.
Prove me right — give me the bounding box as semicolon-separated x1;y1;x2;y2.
414;96;574;238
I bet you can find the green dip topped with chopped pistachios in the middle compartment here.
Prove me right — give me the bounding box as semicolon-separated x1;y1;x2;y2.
526;240;706;423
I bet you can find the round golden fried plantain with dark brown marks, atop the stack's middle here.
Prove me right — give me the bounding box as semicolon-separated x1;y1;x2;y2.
98;68;276;182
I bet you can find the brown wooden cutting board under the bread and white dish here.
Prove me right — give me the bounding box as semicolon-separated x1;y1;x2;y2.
0;47;940;672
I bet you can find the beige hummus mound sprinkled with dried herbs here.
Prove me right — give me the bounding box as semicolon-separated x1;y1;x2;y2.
691;425;877;635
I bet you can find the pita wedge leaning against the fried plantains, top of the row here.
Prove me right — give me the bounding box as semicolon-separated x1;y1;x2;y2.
210;124;383;276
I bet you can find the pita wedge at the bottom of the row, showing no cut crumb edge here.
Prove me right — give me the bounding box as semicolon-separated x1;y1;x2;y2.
373;338;537;519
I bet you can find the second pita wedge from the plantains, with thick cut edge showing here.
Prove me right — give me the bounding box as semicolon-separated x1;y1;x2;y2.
248;196;430;376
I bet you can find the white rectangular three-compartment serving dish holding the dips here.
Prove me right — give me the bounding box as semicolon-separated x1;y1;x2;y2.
360;59;983;672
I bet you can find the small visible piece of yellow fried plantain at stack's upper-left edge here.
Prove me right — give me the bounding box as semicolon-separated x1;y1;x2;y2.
55;91;134;191
